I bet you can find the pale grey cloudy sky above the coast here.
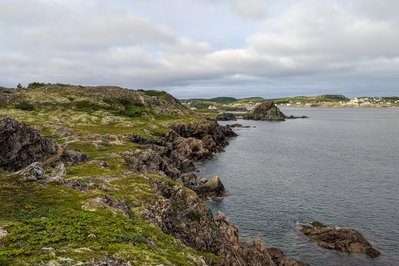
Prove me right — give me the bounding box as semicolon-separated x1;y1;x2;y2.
0;0;399;98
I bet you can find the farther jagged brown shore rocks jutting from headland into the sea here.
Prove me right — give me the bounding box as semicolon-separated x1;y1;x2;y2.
123;121;236;197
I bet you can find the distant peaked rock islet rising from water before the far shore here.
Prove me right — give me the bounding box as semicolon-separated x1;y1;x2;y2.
244;101;287;121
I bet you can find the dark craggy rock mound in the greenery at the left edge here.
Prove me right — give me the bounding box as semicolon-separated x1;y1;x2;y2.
0;117;58;171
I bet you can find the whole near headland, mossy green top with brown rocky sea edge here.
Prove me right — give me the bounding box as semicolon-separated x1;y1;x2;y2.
0;83;305;265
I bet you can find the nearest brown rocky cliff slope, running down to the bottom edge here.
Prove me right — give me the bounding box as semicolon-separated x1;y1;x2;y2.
142;177;306;266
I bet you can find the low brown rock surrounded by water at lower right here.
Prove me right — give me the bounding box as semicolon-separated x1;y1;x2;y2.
300;222;381;258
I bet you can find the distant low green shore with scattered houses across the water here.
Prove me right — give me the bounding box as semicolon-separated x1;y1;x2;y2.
180;94;399;111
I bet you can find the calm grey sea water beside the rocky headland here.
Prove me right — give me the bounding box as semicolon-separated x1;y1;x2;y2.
199;108;399;265
